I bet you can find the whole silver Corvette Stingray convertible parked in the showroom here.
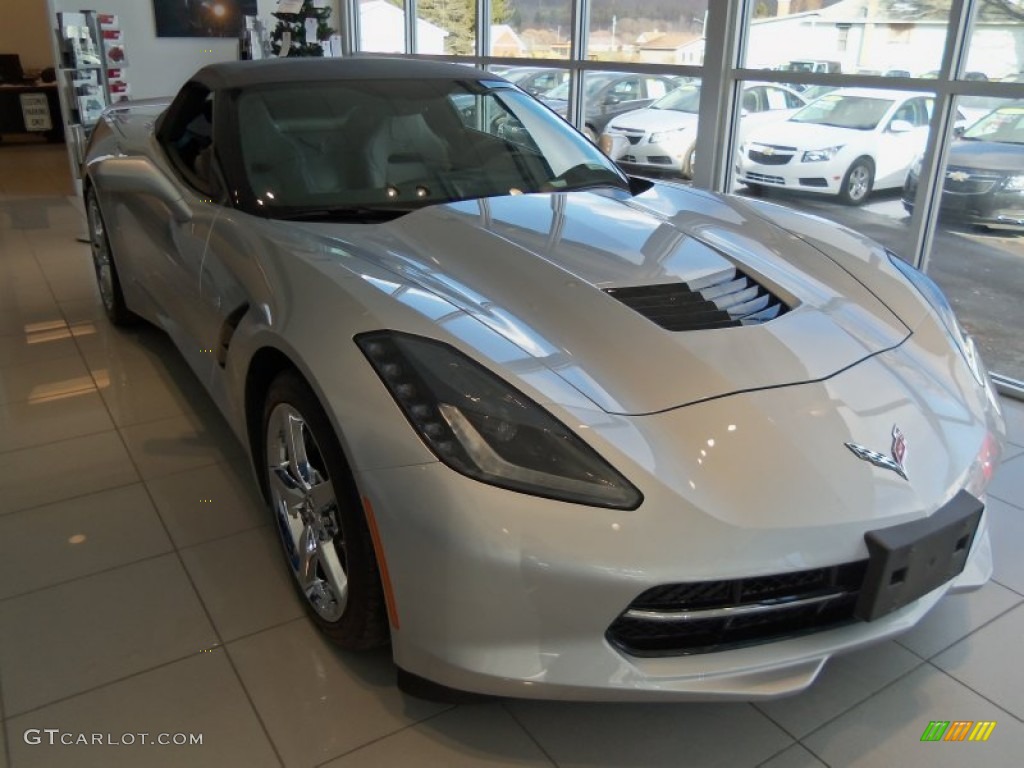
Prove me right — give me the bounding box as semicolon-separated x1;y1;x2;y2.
83;58;1004;699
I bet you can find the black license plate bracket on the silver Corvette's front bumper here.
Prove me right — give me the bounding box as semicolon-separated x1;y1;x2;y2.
854;490;984;622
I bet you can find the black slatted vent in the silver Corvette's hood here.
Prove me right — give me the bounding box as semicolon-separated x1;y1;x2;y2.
605;267;788;331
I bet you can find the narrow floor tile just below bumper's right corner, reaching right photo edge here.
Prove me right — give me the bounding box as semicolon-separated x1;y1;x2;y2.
896;582;1024;658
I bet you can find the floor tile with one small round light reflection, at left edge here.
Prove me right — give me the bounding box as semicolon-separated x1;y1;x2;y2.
0;484;172;599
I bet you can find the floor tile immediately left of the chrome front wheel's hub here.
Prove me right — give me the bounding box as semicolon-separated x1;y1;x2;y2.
145;460;271;548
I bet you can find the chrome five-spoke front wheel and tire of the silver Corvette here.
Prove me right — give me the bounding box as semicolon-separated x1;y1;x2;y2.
260;371;389;650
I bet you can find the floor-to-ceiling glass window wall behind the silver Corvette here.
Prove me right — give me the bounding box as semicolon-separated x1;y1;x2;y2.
344;0;1024;387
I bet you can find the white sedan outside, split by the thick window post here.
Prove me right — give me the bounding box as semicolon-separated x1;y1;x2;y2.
601;83;807;178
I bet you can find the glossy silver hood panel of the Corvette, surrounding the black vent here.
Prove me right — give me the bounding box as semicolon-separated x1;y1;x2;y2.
293;184;909;415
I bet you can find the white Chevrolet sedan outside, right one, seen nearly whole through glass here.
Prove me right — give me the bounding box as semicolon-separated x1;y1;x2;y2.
736;88;934;205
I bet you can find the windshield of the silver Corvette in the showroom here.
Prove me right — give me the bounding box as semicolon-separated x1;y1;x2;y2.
237;79;629;221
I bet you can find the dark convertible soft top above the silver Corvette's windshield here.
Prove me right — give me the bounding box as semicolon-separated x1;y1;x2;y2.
191;56;501;90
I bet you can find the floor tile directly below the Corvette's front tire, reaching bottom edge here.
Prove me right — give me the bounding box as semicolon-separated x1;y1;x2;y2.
227;621;445;768
